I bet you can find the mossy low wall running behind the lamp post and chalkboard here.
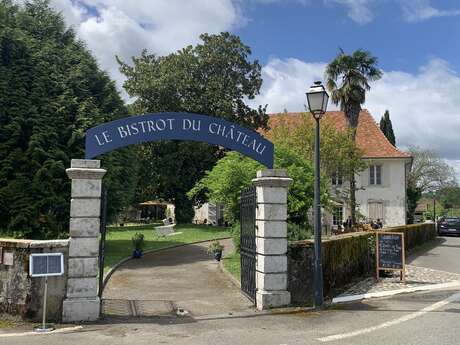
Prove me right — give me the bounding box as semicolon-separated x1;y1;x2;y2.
288;224;437;305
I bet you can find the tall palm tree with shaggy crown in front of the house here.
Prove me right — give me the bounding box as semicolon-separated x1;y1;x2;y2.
325;49;382;225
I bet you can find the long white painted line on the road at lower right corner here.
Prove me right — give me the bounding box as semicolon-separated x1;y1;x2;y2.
317;292;460;343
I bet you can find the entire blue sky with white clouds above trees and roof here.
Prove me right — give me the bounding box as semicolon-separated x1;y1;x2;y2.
44;0;460;177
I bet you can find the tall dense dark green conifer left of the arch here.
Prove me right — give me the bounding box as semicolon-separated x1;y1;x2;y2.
0;0;136;238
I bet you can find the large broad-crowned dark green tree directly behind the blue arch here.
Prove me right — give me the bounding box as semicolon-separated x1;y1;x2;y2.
119;32;268;222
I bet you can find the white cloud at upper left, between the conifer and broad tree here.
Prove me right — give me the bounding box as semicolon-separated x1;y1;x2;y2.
47;0;244;96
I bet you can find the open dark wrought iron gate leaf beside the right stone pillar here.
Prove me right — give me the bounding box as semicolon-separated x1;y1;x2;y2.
240;186;257;302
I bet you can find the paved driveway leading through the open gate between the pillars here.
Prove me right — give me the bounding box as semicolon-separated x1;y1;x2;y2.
103;240;252;316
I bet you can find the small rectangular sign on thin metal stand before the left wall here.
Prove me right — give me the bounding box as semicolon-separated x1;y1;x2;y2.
29;253;64;333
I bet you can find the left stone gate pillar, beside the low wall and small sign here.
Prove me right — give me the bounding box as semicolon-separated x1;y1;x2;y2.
62;159;106;322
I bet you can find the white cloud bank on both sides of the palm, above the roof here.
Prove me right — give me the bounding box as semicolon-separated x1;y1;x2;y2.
252;59;460;164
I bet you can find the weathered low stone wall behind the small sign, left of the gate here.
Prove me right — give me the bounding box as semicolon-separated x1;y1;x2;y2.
0;239;69;322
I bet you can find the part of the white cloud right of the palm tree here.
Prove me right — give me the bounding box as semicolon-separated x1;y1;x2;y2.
366;59;460;159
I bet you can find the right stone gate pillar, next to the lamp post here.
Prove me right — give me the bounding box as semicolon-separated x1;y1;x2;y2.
252;169;292;310
